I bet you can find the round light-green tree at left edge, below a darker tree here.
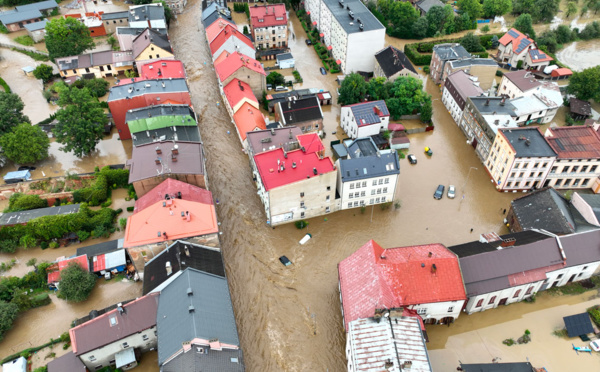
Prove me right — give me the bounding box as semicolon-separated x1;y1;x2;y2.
0;123;50;164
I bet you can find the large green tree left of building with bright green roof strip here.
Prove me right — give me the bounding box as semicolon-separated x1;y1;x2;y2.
53;87;108;157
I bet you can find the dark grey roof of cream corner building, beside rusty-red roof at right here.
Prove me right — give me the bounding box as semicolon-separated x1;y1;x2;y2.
500;128;556;158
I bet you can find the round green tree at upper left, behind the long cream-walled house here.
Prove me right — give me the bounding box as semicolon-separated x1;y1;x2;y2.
46;17;96;61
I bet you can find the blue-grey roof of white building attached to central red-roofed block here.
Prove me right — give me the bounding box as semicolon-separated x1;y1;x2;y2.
340;151;400;182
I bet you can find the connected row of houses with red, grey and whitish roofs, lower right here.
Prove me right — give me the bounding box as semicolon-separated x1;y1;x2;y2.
338;228;600;371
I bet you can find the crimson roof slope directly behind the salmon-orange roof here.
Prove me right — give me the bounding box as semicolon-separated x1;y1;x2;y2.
133;178;213;213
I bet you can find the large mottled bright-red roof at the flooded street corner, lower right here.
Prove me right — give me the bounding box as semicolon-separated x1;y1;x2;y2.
338;240;466;329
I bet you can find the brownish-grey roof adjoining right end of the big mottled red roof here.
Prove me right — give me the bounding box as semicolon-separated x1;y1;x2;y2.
448;230;563;297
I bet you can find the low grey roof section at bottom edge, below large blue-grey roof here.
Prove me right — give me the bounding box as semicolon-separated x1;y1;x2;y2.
161;348;244;372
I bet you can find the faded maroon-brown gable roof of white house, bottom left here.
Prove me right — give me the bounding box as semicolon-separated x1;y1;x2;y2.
69;293;159;355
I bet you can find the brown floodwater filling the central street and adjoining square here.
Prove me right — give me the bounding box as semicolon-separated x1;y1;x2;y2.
169;4;515;371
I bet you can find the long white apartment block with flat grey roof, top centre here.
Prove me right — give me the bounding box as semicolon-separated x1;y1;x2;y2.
304;0;385;74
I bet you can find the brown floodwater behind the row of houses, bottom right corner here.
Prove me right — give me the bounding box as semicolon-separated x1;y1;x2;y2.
427;291;600;372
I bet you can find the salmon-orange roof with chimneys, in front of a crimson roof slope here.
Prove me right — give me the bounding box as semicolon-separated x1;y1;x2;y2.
123;199;219;248
